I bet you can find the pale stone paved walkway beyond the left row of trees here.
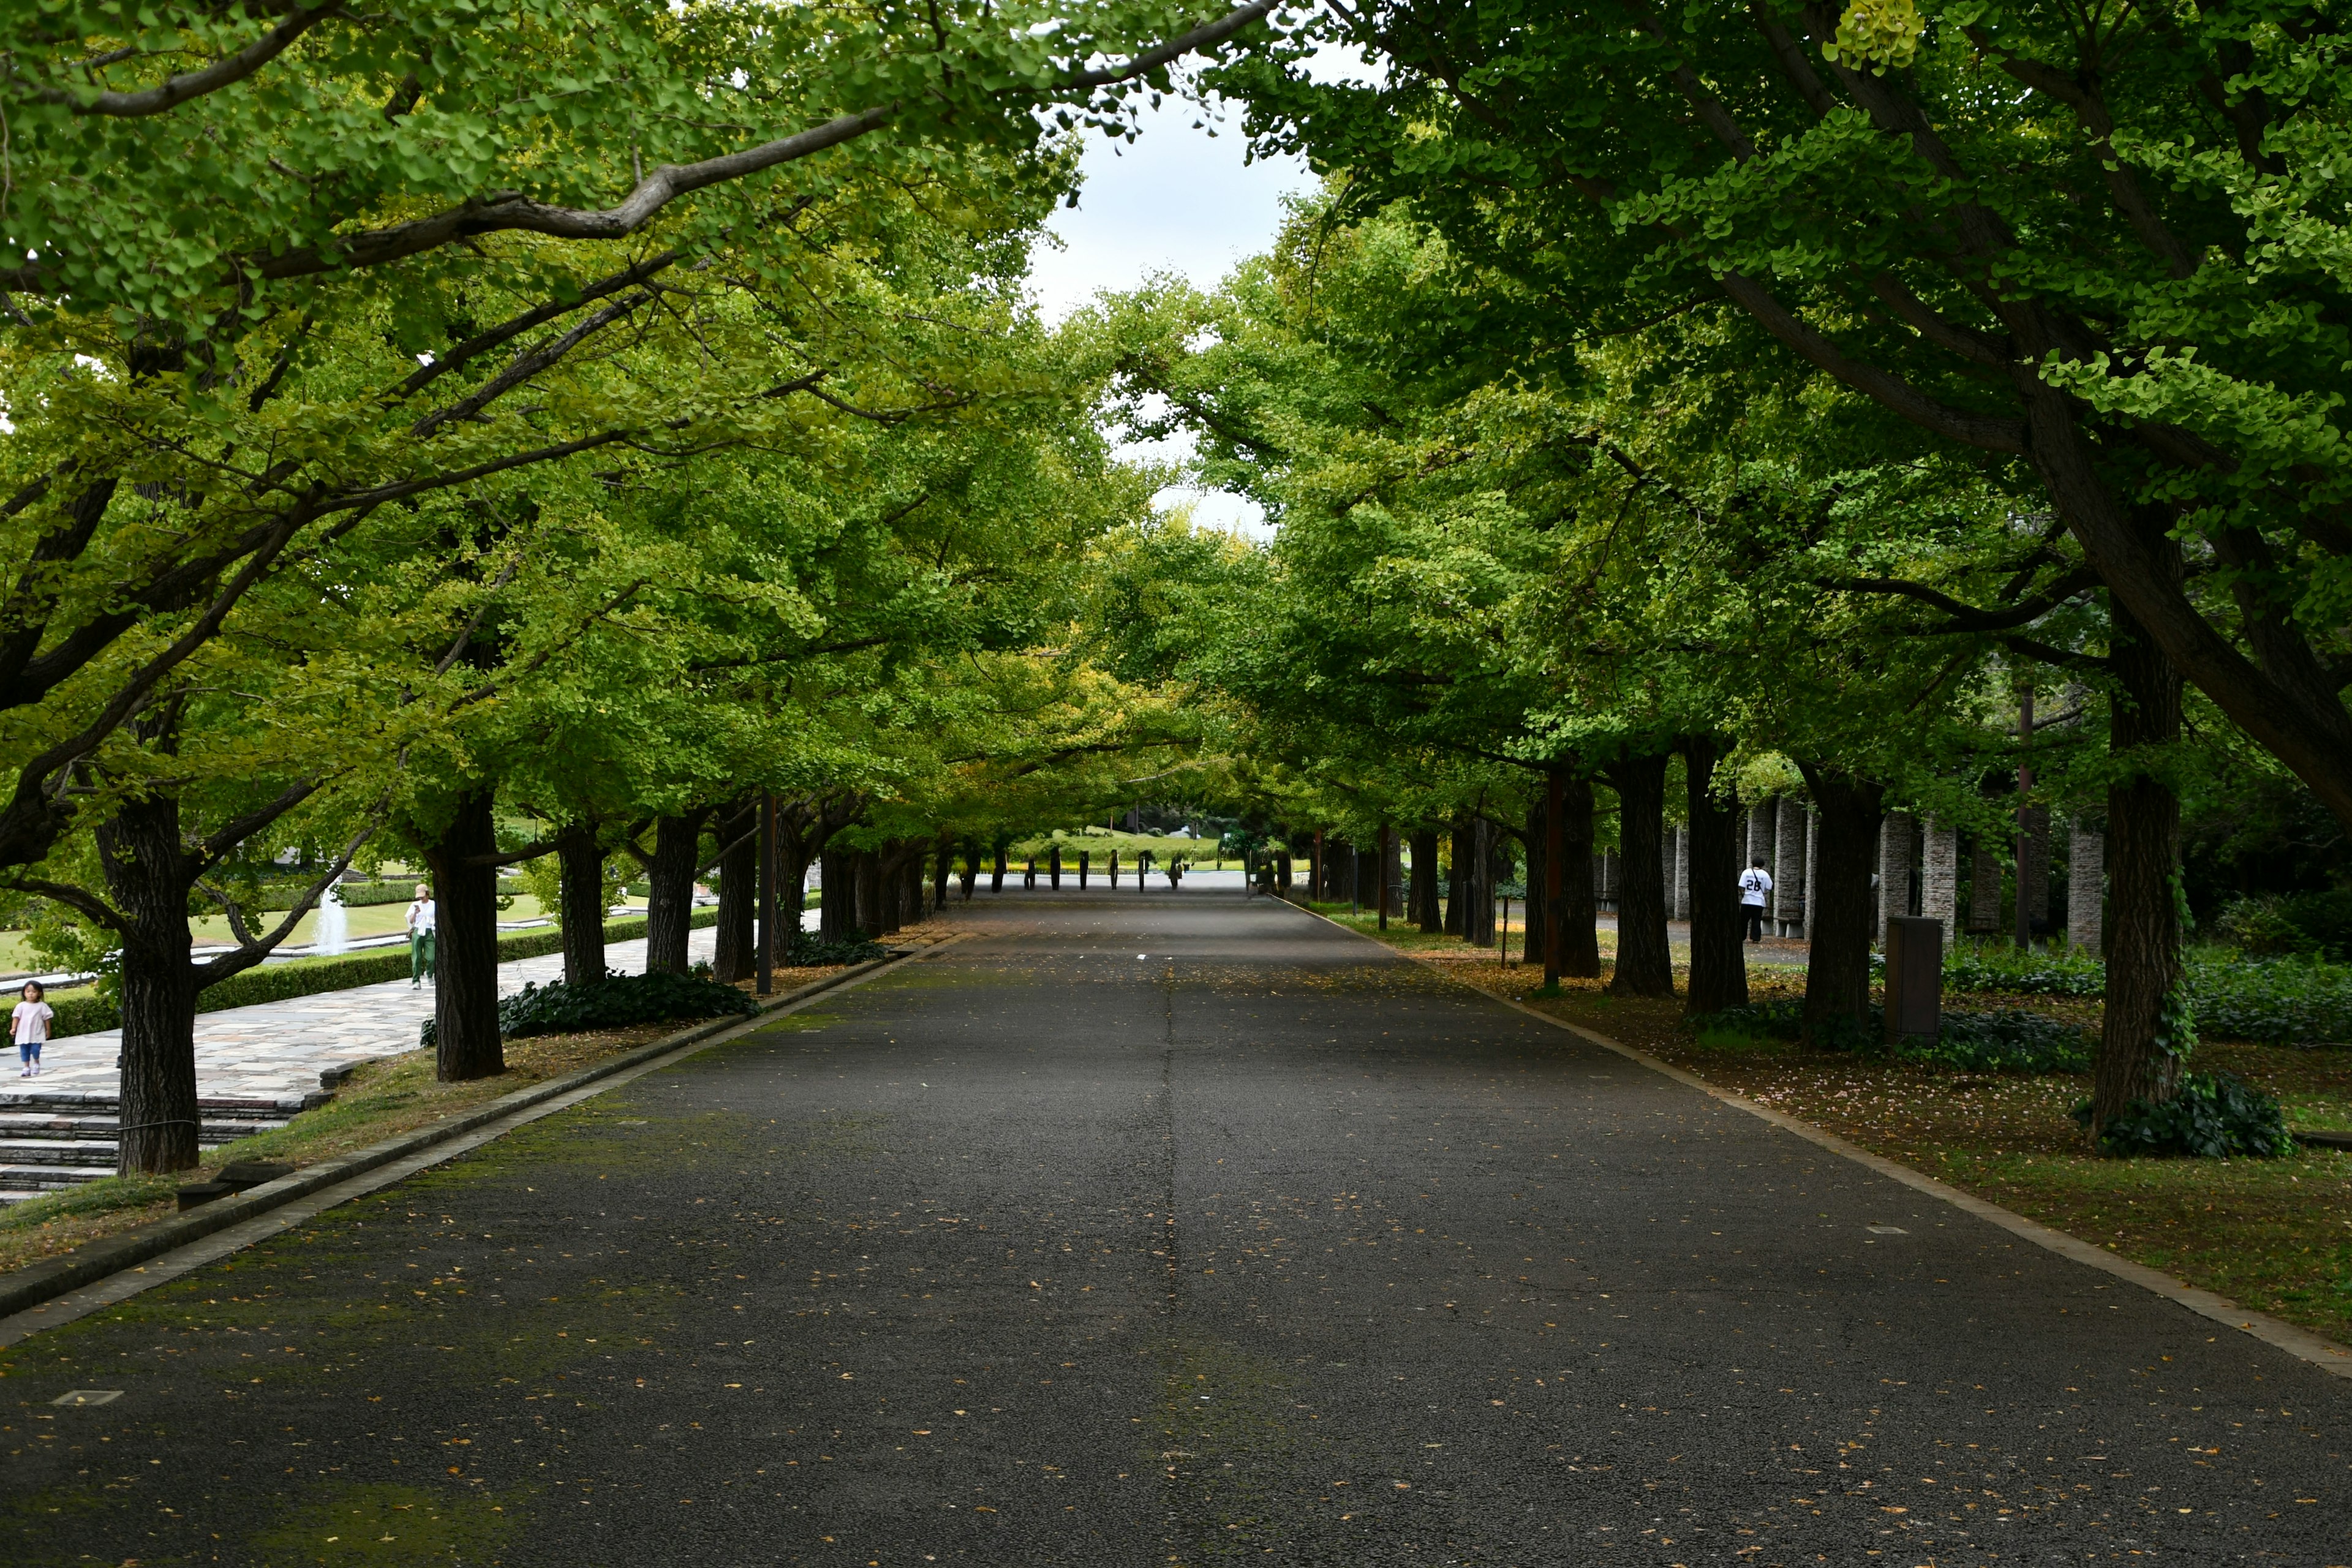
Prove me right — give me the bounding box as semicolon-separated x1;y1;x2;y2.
23;929;717;1100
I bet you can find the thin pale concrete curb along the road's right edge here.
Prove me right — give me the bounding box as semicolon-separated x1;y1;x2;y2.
1291;905;2352;1378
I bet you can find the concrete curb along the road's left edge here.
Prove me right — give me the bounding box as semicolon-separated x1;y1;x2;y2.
0;936;962;1319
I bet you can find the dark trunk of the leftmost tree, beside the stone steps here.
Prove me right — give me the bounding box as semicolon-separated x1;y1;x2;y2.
99;792;198;1175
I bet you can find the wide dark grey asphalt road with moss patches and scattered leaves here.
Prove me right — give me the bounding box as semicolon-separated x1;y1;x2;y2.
0;891;2352;1568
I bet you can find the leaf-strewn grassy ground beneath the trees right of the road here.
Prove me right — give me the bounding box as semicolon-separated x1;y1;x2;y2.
1336;912;2352;1343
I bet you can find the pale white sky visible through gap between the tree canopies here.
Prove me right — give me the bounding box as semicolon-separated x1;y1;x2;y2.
1030;87;1315;533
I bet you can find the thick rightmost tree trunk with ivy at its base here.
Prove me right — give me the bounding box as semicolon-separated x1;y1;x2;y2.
2091;604;2190;1126
